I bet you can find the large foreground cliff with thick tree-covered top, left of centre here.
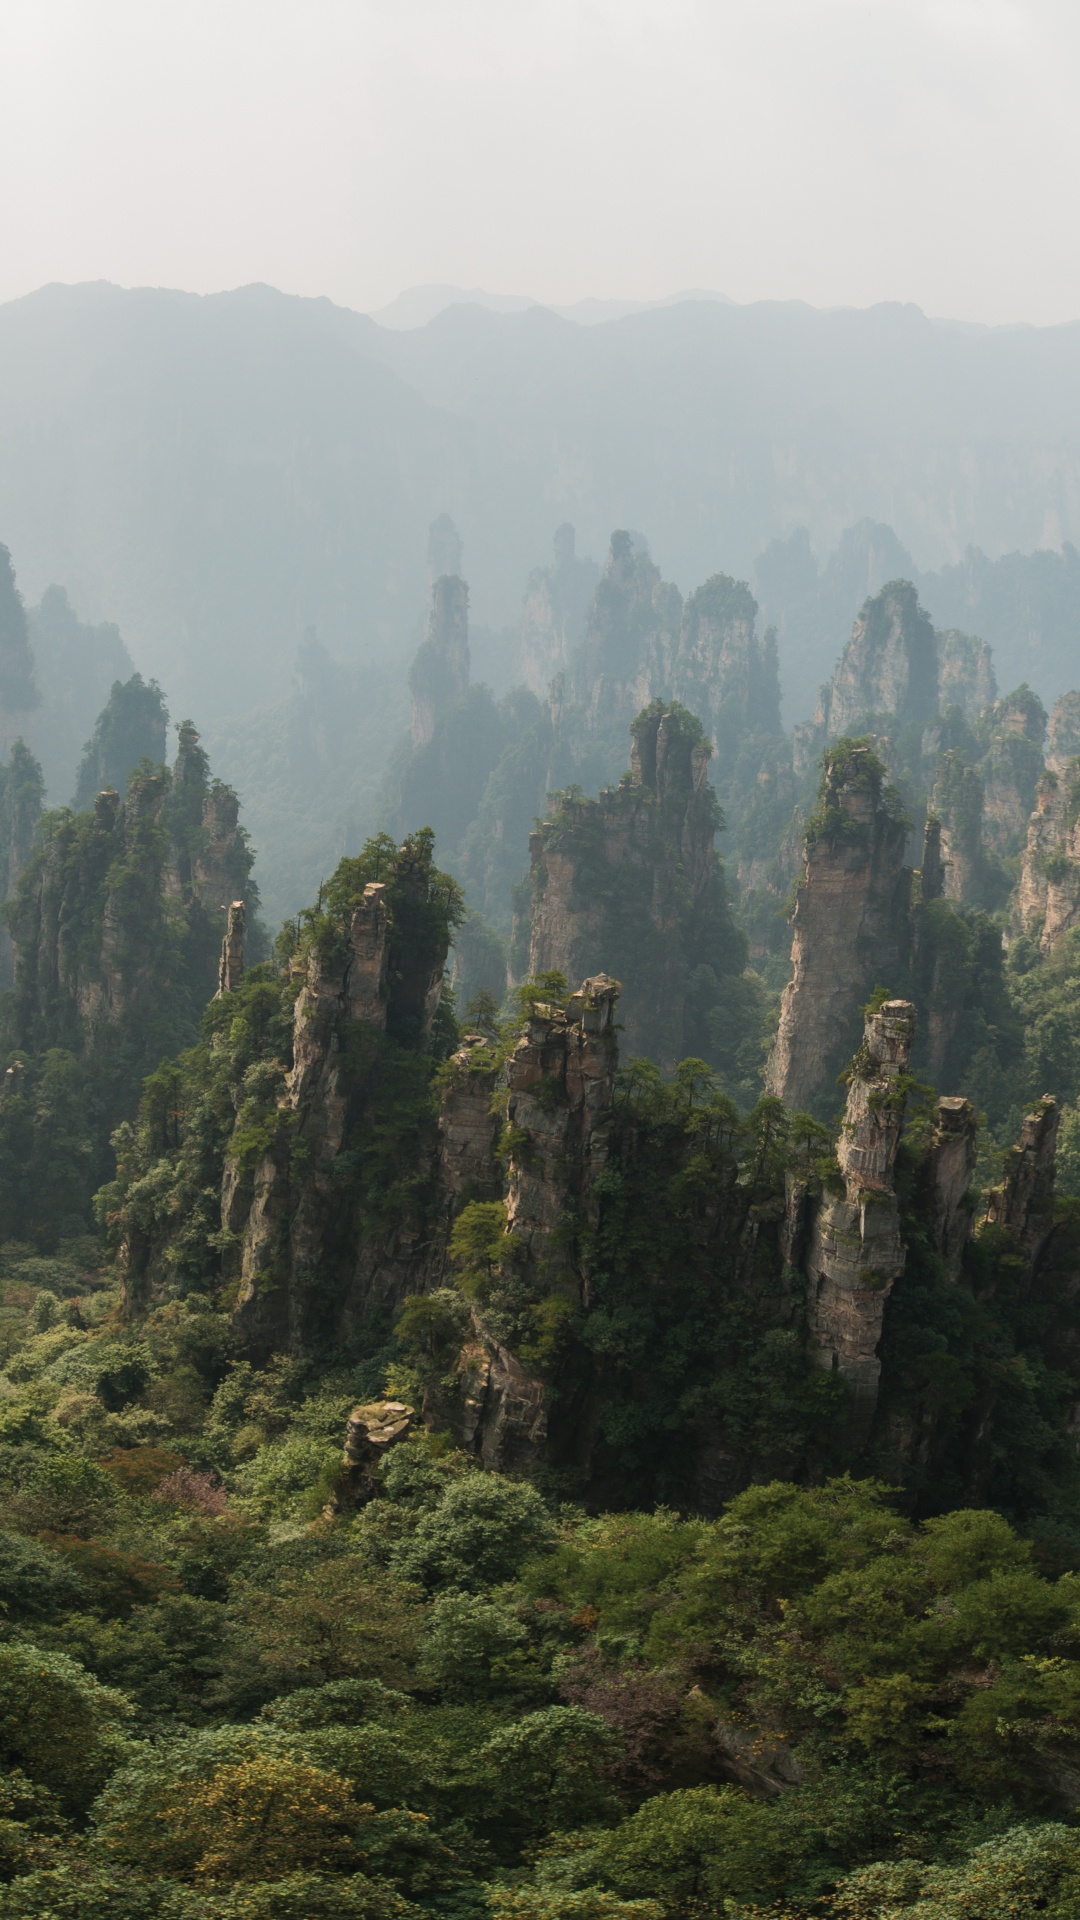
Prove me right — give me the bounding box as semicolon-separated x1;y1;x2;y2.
221;835;457;1352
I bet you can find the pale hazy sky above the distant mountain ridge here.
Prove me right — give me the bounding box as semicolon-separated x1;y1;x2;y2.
0;0;1080;323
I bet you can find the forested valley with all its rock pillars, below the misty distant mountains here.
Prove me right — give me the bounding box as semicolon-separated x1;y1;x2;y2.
0;516;1080;1920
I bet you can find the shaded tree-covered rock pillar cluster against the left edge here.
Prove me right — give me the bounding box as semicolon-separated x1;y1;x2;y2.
0;721;261;1246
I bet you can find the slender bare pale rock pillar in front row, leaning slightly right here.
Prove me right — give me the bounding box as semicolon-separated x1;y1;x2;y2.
807;1000;915;1432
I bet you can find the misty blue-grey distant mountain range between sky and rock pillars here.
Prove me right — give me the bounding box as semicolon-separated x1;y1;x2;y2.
0;282;1080;718
